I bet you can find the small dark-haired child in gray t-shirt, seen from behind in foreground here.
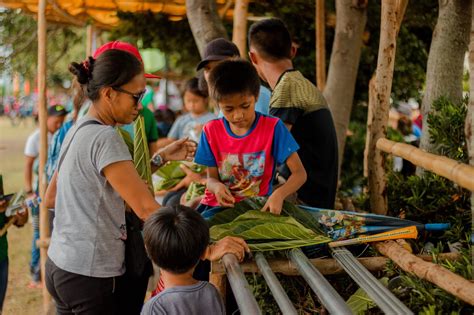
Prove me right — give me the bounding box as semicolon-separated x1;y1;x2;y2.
142;205;225;315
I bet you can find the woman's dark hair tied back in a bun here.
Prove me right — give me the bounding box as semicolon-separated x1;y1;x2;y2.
69;49;143;101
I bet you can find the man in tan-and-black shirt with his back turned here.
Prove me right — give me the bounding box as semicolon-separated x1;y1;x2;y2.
248;19;338;209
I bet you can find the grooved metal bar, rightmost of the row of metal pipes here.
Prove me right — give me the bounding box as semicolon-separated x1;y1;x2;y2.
331;247;413;314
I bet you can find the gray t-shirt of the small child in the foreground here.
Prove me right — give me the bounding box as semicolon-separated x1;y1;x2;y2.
141;281;225;315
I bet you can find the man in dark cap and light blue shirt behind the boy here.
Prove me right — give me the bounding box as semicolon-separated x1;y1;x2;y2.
196;38;271;115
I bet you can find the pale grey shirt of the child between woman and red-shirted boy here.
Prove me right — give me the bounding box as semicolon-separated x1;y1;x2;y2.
168;112;217;141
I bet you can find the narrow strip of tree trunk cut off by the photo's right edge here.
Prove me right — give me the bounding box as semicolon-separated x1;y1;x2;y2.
465;0;474;270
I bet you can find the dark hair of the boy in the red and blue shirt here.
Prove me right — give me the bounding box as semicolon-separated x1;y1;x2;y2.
207;59;260;102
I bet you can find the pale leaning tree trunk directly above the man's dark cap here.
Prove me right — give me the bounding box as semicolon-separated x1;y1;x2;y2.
186;0;227;57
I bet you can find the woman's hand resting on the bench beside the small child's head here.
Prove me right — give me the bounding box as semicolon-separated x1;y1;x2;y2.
204;236;250;261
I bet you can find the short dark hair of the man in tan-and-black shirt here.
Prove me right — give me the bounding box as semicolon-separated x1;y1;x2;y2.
248;18;291;61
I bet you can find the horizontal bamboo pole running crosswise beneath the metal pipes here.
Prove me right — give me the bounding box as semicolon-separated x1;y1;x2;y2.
211;253;460;276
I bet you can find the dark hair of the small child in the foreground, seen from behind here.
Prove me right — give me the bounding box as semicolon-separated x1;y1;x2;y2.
143;205;210;274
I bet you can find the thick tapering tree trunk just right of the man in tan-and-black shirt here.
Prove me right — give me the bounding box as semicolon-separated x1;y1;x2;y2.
323;0;367;174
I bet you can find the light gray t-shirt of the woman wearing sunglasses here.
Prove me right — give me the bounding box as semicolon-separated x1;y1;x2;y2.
48;116;132;278
